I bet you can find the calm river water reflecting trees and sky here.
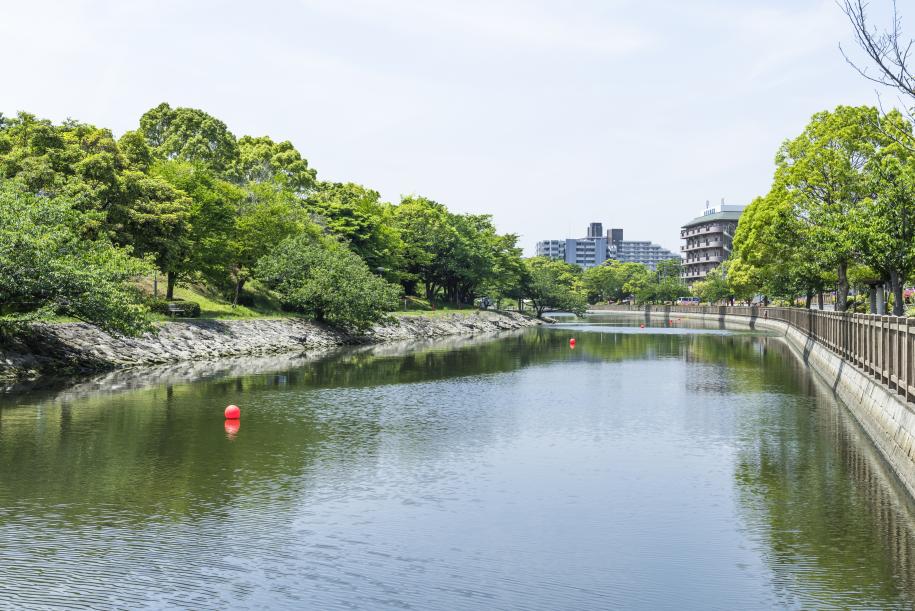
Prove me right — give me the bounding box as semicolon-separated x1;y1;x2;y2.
0;318;915;610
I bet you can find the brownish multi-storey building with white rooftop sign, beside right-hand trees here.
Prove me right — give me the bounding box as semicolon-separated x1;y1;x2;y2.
680;200;746;284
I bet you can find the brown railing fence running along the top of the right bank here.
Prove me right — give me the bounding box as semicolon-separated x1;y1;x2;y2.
602;305;915;401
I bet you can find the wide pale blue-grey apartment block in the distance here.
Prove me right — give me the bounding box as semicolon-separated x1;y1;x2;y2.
537;223;679;269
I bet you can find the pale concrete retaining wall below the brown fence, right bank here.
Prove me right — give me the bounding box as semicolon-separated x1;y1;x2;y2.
600;309;915;499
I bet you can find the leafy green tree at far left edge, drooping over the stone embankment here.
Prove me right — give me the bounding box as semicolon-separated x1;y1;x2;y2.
0;182;151;334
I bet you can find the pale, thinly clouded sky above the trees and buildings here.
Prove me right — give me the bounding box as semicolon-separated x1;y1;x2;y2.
0;0;900;254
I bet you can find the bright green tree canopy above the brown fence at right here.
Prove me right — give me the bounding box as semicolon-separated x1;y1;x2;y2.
727;106;915;315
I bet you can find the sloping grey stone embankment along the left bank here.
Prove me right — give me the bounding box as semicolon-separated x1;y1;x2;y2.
0;312;540;380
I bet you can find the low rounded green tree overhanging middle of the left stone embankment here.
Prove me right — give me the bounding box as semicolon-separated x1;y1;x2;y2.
256;233;400;330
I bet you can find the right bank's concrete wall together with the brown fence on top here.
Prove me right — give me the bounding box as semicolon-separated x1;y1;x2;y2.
592;305;915;499
